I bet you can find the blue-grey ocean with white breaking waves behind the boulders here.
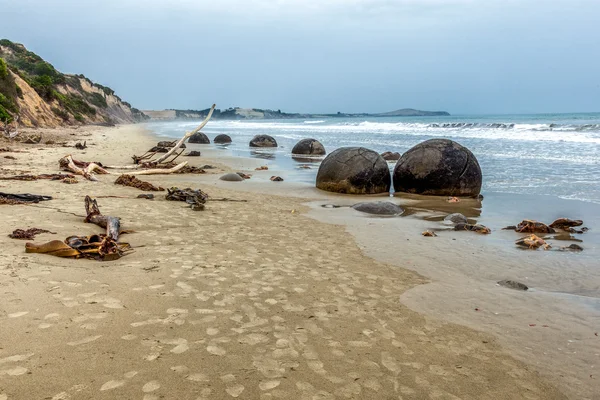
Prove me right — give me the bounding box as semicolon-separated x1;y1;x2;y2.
147;113;600;204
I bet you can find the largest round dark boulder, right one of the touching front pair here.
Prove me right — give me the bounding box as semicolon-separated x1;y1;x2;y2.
393;139;482;197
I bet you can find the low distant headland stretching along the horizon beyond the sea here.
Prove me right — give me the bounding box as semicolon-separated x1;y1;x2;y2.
143;107;450;120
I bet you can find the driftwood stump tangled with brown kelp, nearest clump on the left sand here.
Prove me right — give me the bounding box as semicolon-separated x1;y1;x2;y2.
25;196;132;261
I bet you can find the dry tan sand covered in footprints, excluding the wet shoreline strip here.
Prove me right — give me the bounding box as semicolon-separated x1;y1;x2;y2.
0;126;566;400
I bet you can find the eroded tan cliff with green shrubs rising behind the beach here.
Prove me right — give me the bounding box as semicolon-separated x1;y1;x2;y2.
0;39;148;128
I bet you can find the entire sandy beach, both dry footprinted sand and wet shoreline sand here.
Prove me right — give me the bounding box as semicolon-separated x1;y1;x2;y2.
0;125;600;400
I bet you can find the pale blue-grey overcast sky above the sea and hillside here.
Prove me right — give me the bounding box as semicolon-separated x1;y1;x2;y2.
0;0;600;114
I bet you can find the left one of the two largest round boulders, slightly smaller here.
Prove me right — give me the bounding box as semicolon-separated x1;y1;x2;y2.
317;147;391;194
